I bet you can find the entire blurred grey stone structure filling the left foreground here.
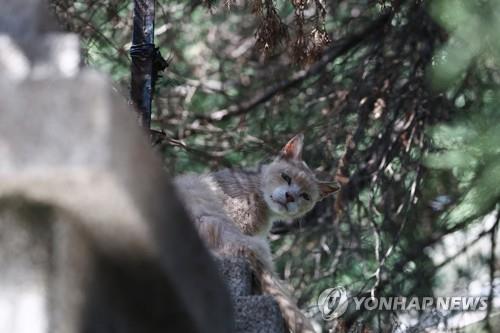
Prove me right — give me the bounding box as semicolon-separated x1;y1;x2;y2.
0;0;281;333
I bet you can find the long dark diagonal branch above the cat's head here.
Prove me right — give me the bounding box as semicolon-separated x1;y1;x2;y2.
200;13;393;122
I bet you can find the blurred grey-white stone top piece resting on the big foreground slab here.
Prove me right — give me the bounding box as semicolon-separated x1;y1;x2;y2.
0;0;80;81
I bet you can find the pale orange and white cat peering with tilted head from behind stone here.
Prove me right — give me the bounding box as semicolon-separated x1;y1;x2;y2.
174;134;339;332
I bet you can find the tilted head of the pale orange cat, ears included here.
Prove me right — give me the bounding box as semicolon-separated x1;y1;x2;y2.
261;134;339;219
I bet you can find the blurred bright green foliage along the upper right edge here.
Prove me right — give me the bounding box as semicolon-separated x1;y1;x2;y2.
427;0;500;224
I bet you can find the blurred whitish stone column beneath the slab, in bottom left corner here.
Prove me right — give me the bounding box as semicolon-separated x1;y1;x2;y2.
0;202;52;333
